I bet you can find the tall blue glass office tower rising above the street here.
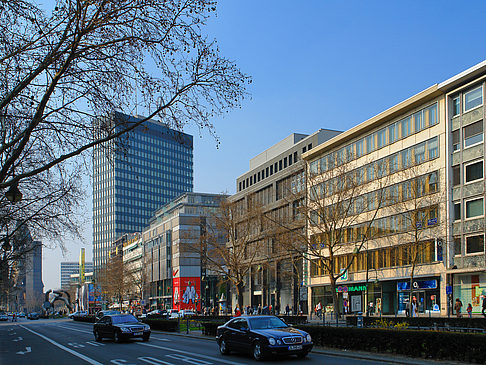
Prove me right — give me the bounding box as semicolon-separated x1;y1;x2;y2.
93;112;193;270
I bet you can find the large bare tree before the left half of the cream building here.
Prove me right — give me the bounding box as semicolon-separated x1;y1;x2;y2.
266;154;388;313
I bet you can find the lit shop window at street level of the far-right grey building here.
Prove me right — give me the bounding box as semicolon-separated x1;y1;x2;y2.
452;273;486;314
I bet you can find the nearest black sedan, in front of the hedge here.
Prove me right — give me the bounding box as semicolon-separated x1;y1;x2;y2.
216;316;313;360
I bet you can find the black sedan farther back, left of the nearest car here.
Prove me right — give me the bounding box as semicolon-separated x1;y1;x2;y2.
93;314;150;342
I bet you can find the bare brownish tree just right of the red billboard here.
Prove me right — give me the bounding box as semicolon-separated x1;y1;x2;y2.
197;200;263;309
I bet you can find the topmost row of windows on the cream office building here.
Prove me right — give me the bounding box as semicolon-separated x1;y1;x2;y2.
311;104;438;173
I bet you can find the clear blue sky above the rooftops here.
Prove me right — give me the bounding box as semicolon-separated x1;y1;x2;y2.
44;0;486;289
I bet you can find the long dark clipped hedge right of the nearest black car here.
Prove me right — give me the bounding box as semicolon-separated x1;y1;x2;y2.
296;325;486;364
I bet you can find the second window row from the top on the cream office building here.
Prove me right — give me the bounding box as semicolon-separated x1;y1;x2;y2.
310;137;439;197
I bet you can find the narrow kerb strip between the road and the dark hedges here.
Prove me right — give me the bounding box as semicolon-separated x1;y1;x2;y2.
152;330;464;365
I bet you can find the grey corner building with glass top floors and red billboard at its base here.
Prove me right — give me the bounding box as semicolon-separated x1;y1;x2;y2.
143;193;226;310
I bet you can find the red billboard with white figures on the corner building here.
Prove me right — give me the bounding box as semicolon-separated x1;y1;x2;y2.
172;277;201;311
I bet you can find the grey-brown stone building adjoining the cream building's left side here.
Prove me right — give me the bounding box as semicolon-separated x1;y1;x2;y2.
230;129;340;310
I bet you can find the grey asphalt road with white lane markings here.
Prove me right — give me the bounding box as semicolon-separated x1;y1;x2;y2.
0;319;398;365
